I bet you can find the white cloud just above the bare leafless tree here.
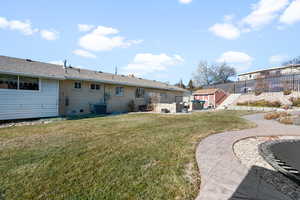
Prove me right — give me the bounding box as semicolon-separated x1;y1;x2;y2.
217;51;253;72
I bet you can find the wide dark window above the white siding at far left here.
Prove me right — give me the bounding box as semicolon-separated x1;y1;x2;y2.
0;74;40;90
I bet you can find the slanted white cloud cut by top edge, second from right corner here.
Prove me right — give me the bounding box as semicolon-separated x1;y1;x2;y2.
242;0;289;29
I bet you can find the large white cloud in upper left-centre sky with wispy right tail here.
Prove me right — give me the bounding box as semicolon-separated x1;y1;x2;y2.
79;26;142;51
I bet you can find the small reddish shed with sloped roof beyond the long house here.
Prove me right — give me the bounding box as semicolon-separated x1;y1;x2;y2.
193;88;227;108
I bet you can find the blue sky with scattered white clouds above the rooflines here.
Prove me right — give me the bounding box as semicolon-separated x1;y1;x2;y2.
0;0;300;83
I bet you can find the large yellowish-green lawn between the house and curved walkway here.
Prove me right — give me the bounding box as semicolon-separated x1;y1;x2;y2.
0;111;253;200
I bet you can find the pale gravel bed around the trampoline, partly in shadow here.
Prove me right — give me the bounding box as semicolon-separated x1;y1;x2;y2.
233;136;300;200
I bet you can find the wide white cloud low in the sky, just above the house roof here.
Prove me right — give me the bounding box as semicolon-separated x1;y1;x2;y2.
123;53;184;76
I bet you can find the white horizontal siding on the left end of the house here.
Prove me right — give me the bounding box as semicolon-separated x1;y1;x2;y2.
0;79;59;120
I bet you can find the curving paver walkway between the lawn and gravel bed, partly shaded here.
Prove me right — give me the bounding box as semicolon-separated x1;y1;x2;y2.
196;114;300;200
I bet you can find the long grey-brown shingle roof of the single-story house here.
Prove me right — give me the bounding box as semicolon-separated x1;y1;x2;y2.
0;56;186;92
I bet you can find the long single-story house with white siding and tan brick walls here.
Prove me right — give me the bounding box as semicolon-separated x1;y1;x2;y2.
0;56;185;120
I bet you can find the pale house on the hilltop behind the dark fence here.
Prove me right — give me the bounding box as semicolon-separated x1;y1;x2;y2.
238;65;300;81
